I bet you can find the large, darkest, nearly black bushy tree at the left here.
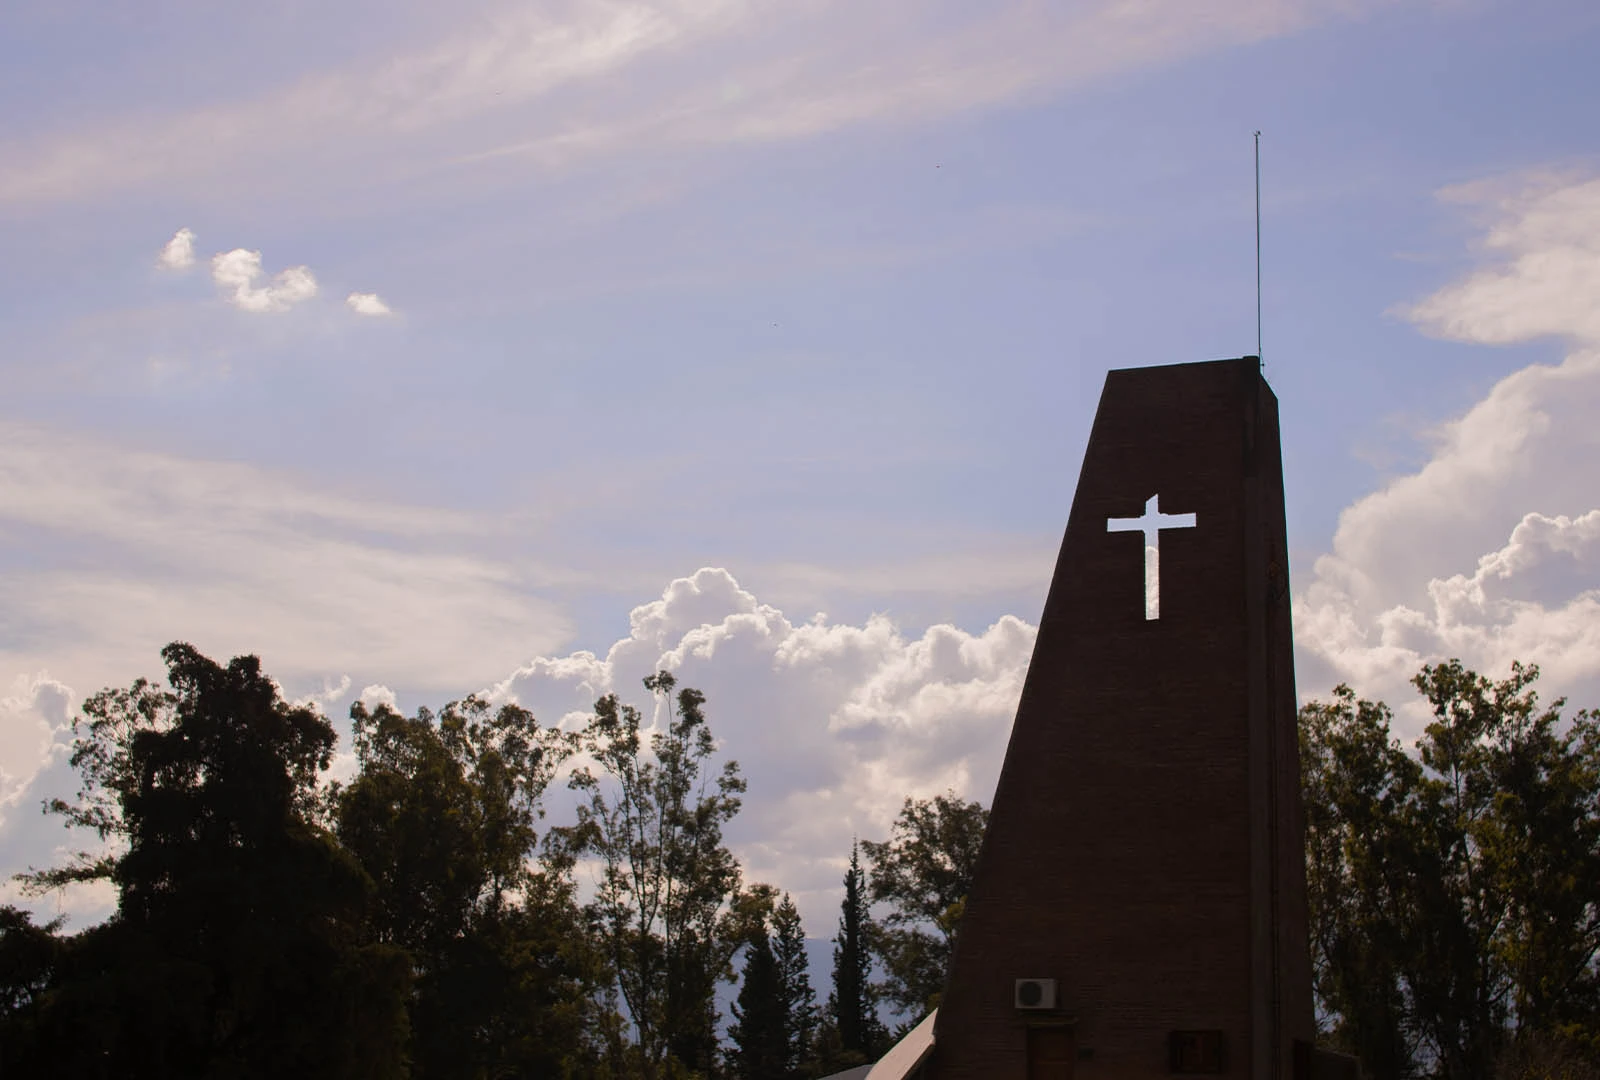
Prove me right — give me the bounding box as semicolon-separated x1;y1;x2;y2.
11;643;410;1077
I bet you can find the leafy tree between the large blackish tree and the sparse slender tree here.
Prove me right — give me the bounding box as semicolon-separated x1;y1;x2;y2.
331;698;600;1080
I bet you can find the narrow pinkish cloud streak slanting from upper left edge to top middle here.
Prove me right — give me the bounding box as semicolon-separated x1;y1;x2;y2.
0;0;754;203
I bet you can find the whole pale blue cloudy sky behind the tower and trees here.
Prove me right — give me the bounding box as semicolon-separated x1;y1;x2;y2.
0;0;1600;936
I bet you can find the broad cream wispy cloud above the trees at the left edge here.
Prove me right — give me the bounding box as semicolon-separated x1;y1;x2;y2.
0;424;570;686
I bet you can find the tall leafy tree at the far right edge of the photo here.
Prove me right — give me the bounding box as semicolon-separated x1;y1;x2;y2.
1411;661;1600;1078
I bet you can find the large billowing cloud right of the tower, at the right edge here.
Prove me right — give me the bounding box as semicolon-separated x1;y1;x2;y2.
1296;174;1600;736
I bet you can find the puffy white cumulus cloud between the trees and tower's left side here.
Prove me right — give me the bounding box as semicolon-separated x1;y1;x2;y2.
488;568;1035;931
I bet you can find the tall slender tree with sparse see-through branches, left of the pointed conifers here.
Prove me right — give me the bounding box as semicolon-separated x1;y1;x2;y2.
555;672;766;1078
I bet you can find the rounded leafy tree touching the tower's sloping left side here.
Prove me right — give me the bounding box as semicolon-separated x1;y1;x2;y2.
861;792;989;1021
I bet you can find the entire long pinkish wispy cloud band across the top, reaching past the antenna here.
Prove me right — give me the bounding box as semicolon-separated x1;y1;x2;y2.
0;0;1389;203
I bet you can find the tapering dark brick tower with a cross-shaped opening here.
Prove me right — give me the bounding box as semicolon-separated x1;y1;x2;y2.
918;357;1323;1080
